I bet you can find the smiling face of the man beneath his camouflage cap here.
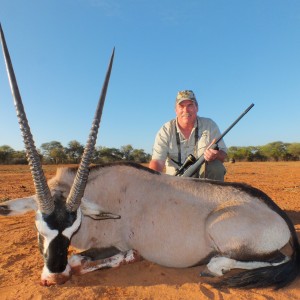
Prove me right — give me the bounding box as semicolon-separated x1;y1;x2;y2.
175;100;198;125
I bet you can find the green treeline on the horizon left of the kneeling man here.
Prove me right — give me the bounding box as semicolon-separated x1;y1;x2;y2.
0;140;151;164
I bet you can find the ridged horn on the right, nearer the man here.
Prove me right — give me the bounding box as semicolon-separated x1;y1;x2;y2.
66;49;115;211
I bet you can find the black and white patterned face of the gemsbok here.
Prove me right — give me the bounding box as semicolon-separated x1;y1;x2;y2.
35;197;81;277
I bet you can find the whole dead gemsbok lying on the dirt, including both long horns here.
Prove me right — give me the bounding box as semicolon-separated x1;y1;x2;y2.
0;26;300;288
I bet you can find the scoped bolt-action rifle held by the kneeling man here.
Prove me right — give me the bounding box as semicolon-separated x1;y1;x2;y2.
175;103;254;177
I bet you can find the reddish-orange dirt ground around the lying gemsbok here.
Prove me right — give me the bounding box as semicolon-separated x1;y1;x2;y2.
0;162;300;300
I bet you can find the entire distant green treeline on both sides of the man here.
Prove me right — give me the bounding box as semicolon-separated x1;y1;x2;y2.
0;140;300;164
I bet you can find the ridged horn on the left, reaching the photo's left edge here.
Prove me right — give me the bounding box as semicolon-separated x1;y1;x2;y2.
0;24;54;214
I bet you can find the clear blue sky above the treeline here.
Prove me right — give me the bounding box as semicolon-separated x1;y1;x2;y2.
0;0;300;153
